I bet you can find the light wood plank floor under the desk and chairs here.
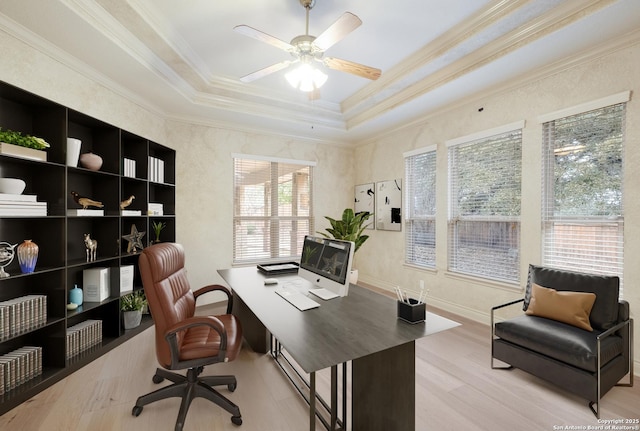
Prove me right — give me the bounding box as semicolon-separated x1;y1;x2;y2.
0;304;640;431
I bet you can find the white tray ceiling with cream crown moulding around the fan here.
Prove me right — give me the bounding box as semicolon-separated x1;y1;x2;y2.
0;0;640;143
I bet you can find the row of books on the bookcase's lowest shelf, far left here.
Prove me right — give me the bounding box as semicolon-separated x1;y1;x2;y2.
0;346;42;394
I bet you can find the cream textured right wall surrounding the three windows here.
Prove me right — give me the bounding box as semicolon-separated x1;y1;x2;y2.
356;44;640;369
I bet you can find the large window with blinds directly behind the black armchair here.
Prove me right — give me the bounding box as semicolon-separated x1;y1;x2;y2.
542;93;628;292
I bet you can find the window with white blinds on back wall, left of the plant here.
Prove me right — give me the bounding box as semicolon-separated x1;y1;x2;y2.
233;155;313;264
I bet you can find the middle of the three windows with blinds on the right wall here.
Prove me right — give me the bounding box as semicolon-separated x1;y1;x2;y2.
447;122;524;283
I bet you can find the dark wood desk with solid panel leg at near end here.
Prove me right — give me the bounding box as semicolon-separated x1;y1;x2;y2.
218;267;458;431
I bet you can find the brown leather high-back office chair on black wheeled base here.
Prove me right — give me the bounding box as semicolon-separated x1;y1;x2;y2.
132;243;242;431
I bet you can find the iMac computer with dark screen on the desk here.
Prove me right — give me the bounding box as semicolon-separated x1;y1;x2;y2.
298;235;355;296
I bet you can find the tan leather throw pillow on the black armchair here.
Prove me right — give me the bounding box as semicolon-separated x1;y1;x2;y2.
525;283;596;331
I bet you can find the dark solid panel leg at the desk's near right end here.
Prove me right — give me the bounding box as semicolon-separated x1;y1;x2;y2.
351;341;416;431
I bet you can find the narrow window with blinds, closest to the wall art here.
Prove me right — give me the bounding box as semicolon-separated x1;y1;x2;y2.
404;147;436;268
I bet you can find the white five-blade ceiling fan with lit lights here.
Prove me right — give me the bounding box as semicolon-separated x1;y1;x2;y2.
234;0;381;92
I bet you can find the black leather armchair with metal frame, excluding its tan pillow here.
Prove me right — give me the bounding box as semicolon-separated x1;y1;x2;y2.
491;265;633;418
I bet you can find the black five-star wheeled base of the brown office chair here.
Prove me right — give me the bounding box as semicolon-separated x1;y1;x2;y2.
131;367;242;431
